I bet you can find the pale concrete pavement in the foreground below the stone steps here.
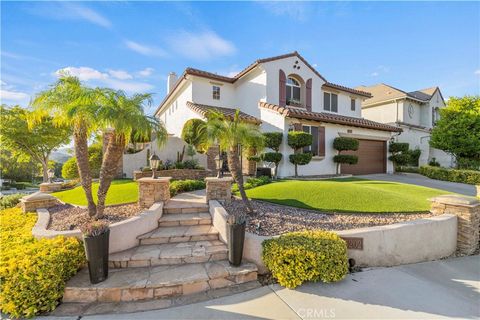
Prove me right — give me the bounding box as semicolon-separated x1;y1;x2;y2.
72;255;480;320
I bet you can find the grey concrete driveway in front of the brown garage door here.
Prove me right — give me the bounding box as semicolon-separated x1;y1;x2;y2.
356;173;477;196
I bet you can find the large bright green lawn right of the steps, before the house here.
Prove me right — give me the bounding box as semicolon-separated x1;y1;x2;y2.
246;178;451;213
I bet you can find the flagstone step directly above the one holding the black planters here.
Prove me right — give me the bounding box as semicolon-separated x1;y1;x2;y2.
109;240;228;268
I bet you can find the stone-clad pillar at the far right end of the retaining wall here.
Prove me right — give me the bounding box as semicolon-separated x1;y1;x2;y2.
430;195;480;255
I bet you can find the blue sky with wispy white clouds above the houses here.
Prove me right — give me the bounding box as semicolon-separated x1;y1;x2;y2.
1;1;480;112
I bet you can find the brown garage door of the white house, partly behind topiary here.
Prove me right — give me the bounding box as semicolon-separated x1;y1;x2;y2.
342;140;387;174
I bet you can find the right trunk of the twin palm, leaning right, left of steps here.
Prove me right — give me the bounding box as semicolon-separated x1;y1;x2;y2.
97;130;125;219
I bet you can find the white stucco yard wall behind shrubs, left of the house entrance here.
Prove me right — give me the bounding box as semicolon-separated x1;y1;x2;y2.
123;136;207;178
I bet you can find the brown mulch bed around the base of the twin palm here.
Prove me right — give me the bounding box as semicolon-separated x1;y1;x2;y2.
48;203;142;231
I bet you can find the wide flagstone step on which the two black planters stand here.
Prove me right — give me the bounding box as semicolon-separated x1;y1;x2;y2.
63;260;257;303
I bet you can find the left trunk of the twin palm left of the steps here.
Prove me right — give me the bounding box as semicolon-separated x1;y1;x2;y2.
73;125;97;217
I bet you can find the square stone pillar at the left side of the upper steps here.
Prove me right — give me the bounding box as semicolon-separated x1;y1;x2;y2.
137;177;171;208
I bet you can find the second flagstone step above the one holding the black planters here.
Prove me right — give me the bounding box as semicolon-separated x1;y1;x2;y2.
138;225;218;244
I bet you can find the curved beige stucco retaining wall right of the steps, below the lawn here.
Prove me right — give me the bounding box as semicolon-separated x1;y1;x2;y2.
243;214;457;273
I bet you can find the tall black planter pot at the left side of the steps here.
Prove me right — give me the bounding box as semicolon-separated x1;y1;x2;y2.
83;230;110;284
